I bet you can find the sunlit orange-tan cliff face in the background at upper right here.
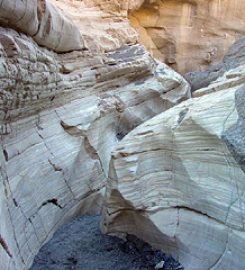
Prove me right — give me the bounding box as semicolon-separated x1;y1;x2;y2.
129;0;245;73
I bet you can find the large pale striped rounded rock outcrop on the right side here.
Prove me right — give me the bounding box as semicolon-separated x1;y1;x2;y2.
102;67;245;270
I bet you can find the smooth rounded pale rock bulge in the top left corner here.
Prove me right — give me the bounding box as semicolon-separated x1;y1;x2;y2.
0;0;84;52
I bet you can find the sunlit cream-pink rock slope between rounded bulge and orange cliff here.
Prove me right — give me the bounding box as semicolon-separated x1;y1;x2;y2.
50;0;138;52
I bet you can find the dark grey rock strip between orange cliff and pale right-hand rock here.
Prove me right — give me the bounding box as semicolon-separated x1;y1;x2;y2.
184;36;245;91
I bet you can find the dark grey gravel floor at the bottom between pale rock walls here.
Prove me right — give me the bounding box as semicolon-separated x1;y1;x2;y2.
30;216;184;270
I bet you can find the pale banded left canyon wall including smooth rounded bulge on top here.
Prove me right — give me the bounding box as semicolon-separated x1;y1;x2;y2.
0;0;190;270
